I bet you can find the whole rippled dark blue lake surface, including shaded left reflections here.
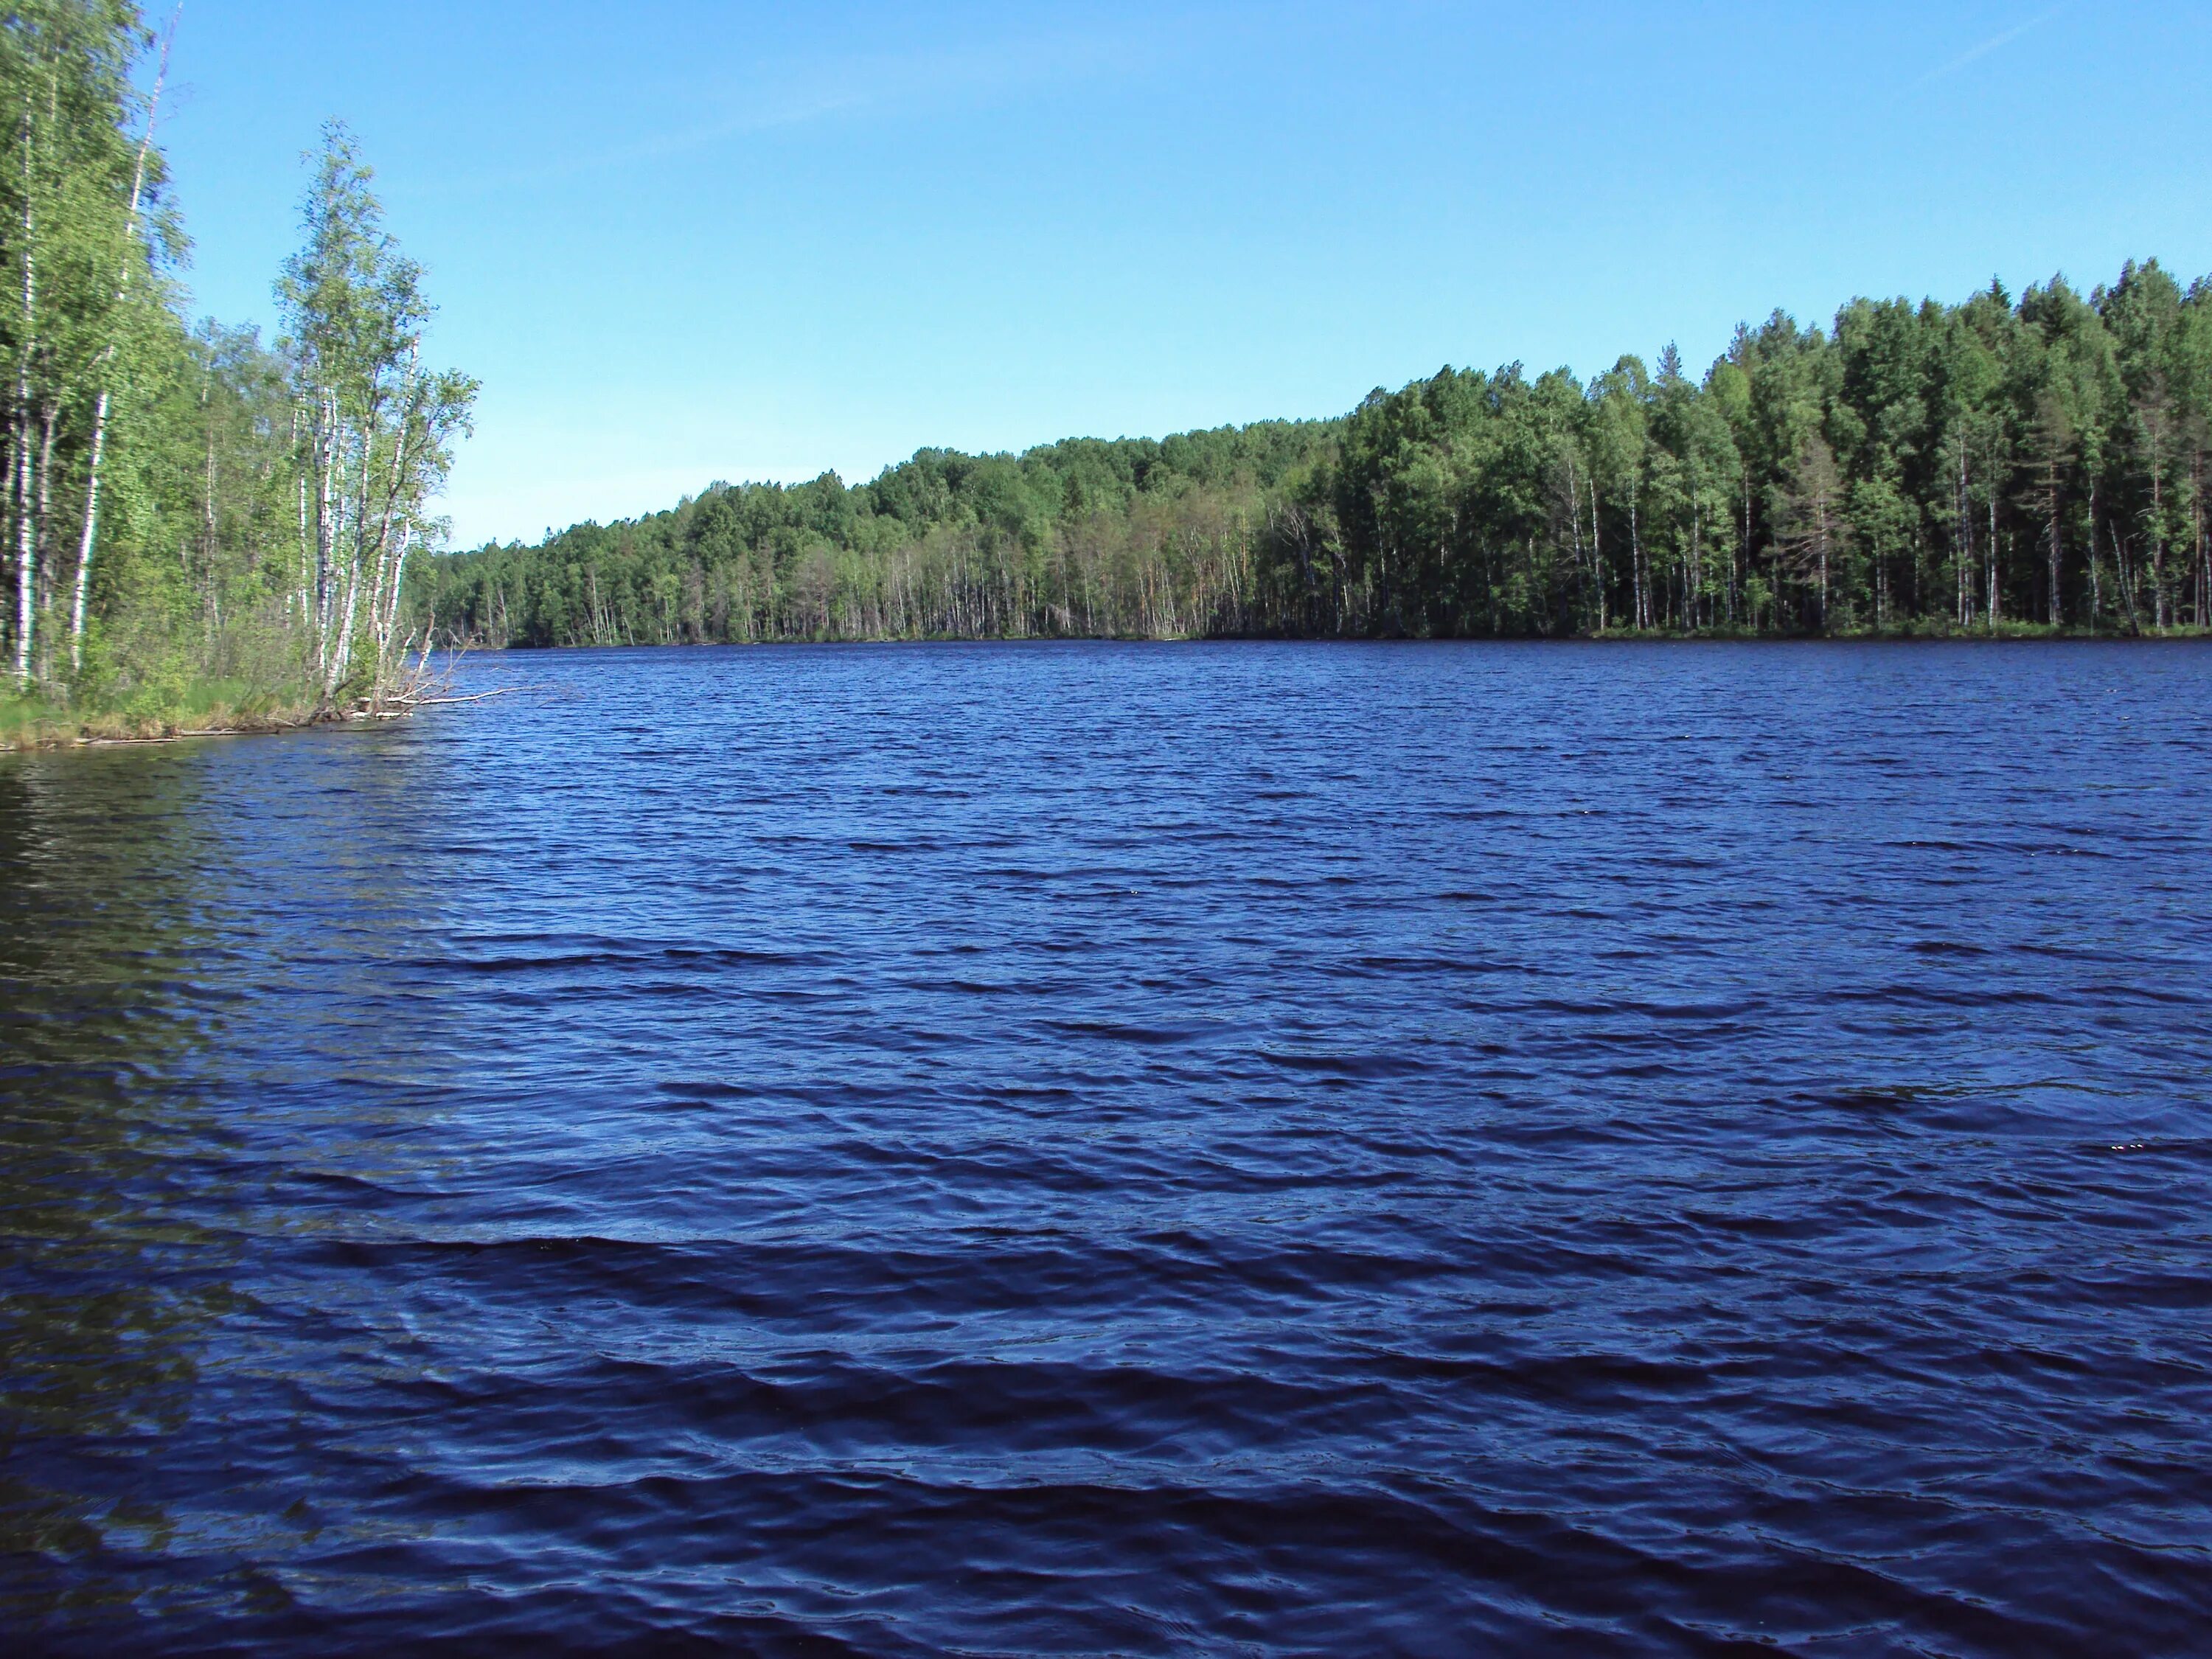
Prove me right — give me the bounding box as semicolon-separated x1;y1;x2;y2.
0;646;2212;1655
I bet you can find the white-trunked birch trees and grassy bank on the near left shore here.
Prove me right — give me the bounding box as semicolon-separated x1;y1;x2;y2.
0;0;476;737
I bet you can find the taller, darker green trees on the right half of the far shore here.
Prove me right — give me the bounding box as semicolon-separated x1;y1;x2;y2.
1292;263;2212;635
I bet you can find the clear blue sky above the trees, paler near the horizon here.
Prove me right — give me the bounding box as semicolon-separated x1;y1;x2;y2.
148;0;2212;544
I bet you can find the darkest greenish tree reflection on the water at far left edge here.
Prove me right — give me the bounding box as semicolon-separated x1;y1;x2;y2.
0;754;234;1619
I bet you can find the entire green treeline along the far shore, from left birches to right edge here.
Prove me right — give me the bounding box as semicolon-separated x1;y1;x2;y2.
416;261;2212;646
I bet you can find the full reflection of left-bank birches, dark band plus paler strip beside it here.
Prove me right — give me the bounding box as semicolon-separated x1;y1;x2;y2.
0;734;451;1635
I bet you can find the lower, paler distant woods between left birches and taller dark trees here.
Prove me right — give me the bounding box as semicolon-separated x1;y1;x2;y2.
414;422;1336;646
